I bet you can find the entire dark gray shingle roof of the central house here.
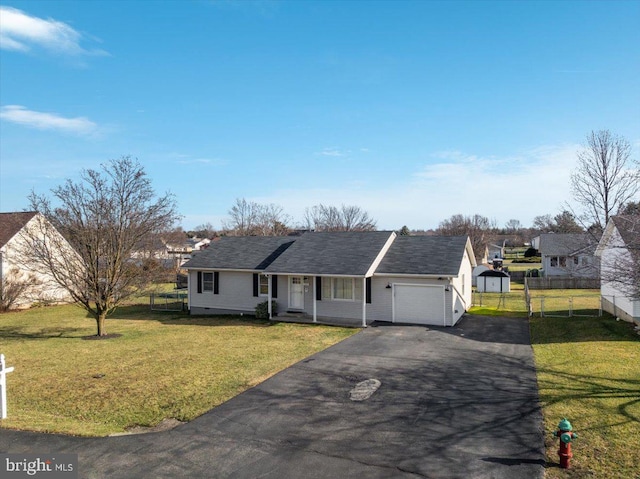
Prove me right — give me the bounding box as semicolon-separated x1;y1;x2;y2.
185;231;467;276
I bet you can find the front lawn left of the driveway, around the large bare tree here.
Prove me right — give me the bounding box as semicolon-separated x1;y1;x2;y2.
0;305;357;436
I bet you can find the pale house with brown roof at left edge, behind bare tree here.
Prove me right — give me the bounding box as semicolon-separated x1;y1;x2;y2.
0;211;71;308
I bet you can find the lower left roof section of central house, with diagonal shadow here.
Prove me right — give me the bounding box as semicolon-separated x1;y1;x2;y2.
183;236;295;271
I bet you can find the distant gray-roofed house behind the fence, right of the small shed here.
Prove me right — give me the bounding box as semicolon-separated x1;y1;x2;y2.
537;233;600;278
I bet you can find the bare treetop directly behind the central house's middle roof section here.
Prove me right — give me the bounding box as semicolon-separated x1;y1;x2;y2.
304;204;376;231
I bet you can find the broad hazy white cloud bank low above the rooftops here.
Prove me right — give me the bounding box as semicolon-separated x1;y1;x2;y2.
248;145;577;229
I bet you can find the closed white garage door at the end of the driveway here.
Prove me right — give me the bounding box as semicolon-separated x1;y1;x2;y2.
393;284;445;326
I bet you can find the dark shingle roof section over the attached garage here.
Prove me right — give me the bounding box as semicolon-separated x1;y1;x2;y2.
376;236;467;276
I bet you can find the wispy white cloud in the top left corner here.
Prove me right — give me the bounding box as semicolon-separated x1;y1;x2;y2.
0;6;106;55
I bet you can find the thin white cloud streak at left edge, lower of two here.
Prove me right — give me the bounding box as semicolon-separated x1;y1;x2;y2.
0;105;98;136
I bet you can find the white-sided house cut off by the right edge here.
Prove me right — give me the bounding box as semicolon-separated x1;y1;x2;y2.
596;216;640;325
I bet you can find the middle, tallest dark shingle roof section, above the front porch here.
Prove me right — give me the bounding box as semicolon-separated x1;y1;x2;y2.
267;231;393;276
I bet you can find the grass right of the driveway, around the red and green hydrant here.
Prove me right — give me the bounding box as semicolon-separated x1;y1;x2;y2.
530;315;640;479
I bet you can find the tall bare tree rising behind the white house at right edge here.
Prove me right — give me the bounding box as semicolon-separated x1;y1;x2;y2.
571;130;640;232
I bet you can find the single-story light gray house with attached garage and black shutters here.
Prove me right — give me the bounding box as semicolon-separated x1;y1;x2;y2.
184;231;475;326
